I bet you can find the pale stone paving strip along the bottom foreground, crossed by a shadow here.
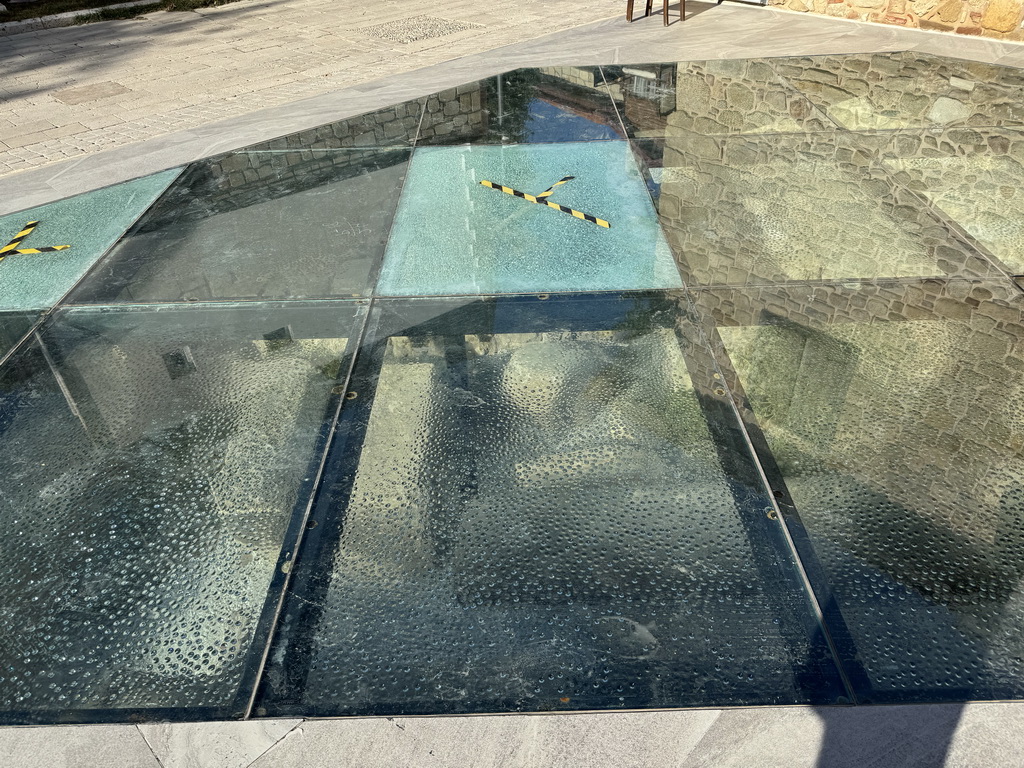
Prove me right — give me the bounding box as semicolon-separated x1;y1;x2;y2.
0;703;1024;768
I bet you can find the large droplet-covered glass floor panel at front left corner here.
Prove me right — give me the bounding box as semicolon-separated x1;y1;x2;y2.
0;302;362;722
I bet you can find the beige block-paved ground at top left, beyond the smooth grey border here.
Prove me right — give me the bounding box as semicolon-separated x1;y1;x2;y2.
0;0;623;176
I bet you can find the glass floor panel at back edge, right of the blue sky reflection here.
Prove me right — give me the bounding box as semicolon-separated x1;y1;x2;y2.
603;58;836;138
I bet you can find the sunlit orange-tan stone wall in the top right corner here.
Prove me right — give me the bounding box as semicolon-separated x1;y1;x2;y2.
768;0;1024;40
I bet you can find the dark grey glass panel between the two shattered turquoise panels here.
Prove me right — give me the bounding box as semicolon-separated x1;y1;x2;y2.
71;148;410;303
